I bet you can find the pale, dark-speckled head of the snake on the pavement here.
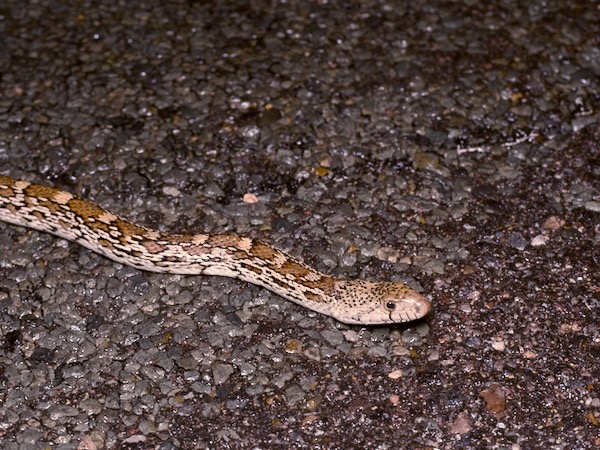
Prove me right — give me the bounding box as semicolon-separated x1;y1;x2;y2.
330;280;431;325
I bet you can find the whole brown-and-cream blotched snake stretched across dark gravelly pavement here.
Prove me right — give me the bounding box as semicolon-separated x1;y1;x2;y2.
0;175;431;324
